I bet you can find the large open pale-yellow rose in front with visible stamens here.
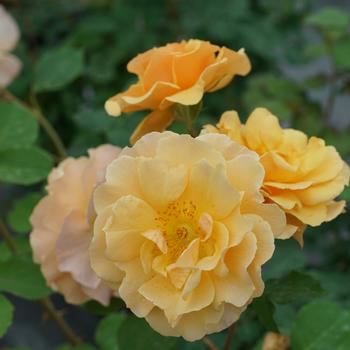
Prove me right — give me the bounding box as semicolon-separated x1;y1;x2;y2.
89;132;286;341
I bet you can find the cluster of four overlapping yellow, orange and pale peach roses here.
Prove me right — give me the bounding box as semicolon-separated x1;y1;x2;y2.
31;40;349;341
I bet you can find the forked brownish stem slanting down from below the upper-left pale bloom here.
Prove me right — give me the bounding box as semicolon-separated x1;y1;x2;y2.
1;90;67;160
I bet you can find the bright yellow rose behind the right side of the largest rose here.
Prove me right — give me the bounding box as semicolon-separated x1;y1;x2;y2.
203;108;349;244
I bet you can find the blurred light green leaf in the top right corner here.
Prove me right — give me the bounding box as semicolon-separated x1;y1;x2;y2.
306;7;350;30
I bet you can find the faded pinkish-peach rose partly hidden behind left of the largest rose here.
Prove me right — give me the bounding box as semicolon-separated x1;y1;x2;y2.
30;145;119;305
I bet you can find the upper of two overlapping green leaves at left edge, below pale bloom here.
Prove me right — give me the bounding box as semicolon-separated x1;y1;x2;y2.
0;101;38;150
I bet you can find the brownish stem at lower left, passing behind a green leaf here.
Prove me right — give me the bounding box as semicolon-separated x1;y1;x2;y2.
0;219;81;346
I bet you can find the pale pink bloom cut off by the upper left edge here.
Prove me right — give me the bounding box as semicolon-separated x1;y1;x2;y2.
0;5;21;88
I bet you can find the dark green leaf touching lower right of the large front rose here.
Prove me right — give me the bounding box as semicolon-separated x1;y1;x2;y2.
265;271;324;304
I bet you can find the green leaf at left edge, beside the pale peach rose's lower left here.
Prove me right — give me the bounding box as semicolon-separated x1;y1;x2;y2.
0;255;51;300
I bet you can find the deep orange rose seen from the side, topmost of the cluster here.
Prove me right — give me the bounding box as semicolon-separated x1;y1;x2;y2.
105;40;250;143
